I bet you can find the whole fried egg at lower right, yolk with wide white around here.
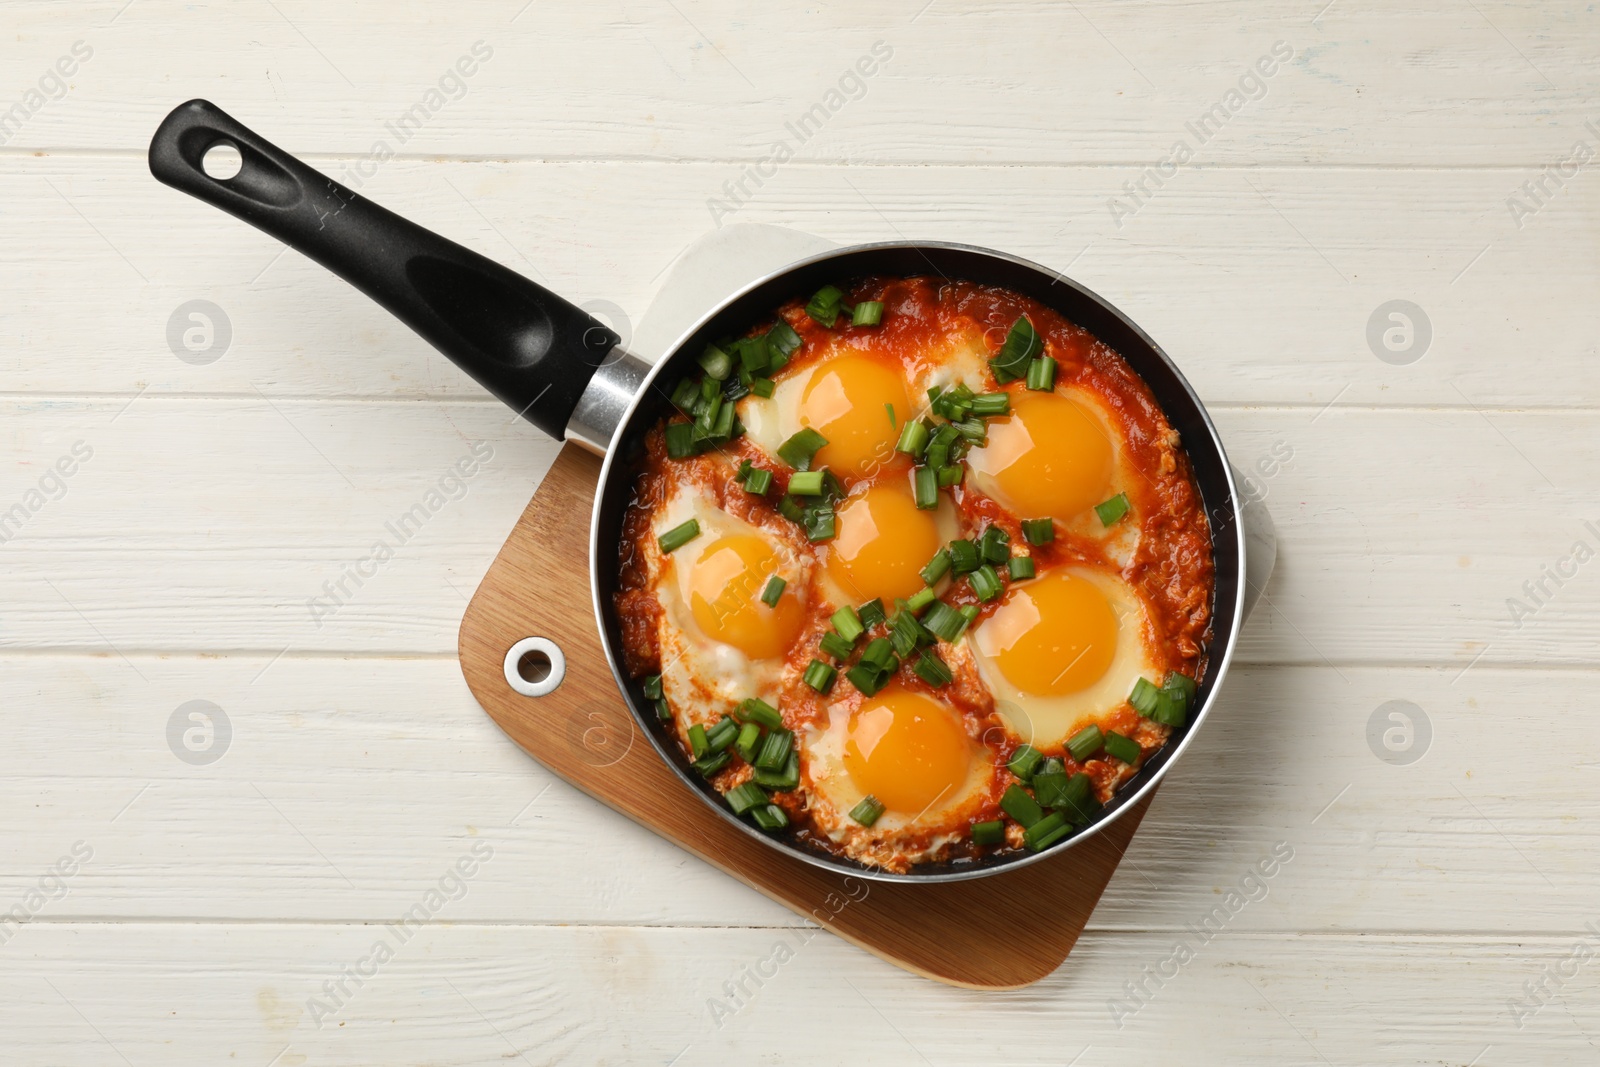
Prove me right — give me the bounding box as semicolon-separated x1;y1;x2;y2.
970;566;1162;750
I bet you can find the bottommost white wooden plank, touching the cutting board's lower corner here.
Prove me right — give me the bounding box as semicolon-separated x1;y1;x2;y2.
0;921;1600;1067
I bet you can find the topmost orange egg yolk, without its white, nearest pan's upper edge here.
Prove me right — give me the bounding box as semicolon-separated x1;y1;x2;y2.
800;355;912;478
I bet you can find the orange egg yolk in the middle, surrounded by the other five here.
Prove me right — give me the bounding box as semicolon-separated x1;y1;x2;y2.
827;478;939;603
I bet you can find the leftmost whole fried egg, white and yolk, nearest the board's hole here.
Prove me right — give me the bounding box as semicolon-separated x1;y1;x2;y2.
650;485;814;723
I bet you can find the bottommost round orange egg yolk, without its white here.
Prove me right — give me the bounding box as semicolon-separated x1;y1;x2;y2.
845;686;973;817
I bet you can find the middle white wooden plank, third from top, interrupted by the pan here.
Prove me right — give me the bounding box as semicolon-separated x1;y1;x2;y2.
0;397;1600;677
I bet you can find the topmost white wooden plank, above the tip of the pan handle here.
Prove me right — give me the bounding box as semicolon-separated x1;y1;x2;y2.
0;0;1597;167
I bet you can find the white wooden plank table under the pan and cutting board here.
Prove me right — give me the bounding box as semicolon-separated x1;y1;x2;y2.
0;0;1600;1067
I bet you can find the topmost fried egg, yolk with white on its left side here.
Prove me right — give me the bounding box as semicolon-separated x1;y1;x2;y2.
739;350;914;485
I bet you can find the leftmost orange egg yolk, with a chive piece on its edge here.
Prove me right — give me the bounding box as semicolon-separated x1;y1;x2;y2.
688;534;805;659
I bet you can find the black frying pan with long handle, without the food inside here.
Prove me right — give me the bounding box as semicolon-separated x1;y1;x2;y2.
150;99;1246;881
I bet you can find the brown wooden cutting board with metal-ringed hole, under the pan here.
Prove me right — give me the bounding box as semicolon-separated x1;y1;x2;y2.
461;445;1155;989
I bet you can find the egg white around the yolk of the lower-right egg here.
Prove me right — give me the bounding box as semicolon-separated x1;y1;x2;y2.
965;566;1160;750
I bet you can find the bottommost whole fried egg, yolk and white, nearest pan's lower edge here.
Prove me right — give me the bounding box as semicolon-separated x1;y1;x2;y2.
803;683;997;857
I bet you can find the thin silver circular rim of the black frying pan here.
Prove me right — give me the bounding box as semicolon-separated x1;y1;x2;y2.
589;240;1248;885
